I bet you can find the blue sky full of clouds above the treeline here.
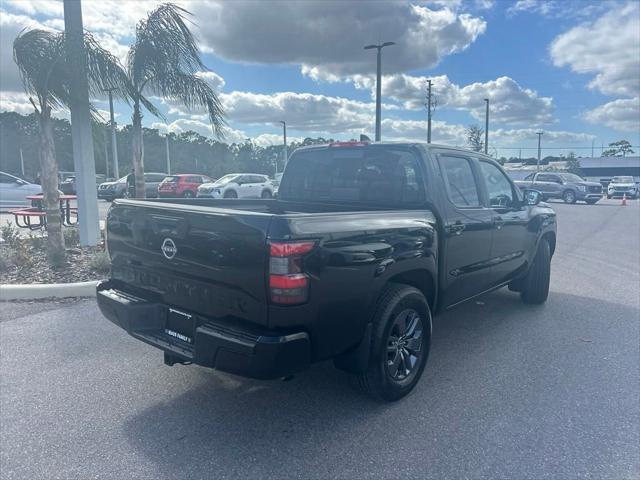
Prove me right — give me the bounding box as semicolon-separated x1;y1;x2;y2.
0;0;640;156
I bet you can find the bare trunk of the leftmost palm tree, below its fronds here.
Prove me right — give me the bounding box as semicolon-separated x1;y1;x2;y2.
38;106;66;266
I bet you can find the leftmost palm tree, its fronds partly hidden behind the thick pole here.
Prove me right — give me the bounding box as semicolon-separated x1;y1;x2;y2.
13;29;128;265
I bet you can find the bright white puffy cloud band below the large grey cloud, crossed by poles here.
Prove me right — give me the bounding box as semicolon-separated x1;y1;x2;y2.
350;73;553;126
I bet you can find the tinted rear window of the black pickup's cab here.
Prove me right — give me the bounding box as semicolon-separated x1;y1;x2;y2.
278;145;424;205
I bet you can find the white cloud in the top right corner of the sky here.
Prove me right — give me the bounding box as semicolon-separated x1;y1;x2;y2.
550;2;640;97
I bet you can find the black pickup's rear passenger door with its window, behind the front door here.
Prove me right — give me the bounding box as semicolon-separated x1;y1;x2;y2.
436;151;493;306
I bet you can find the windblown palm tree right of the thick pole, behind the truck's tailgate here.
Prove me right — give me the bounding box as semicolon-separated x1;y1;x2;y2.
127;3;225;198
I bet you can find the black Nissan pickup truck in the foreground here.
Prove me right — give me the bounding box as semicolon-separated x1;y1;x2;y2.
97;142;556;400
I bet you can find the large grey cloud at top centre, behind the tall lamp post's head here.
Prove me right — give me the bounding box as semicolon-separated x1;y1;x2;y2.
191;1;486;77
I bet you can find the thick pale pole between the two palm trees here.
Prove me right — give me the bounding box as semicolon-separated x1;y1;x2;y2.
63;0;100;246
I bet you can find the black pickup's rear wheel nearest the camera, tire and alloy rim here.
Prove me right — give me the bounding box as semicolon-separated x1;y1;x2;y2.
355;283;431;402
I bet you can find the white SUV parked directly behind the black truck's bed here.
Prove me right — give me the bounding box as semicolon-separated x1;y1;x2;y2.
198;173;274;198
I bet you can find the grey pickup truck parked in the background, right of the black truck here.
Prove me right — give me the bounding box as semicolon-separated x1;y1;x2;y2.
515;172;603;205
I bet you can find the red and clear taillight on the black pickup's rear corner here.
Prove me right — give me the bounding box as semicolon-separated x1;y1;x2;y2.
269;242;315;305
